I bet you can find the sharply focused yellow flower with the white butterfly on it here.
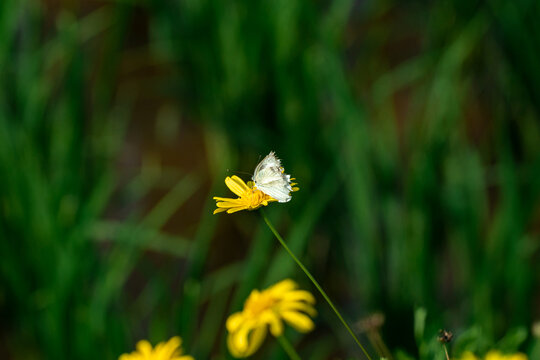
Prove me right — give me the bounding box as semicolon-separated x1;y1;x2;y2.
214;175;277;214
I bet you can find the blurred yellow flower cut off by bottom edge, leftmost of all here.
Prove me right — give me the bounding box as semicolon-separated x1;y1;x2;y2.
118;336;194;360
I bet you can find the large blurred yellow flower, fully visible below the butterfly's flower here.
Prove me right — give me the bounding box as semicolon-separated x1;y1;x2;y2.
227;279;317;358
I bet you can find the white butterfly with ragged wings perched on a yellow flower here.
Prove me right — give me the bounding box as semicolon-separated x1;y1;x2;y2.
251;151;292;202
